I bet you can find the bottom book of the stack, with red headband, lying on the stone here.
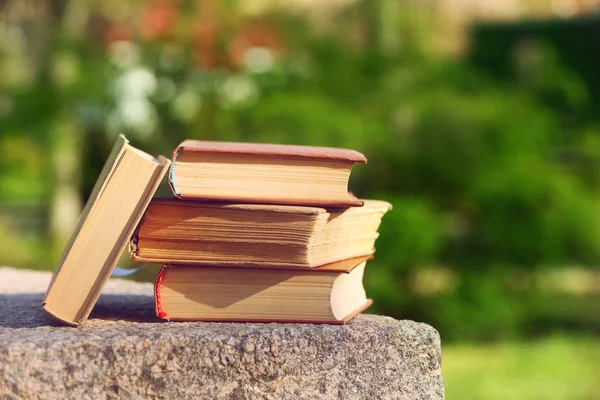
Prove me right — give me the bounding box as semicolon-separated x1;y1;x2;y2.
154;257;372;324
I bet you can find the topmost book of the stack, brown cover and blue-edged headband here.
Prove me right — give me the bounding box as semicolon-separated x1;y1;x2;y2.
169;140;367;207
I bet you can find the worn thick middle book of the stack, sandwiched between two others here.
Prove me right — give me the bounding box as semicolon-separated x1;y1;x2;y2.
130;199;391;268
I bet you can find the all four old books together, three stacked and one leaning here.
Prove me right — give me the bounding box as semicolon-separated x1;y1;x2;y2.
44;138;390;325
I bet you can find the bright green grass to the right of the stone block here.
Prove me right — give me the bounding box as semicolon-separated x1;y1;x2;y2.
442;336;600;400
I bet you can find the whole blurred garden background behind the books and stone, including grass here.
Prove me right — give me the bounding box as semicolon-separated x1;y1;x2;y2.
0;0;600;400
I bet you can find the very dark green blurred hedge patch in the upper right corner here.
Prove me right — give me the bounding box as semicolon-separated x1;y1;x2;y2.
467;16;600;120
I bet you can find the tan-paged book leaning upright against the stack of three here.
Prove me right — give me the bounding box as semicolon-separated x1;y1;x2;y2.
42;135;170;325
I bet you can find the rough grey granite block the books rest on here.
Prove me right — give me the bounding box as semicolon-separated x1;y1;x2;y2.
0;268;444;399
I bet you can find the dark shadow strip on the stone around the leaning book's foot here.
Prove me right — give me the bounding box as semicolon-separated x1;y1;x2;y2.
0;293;157;329
